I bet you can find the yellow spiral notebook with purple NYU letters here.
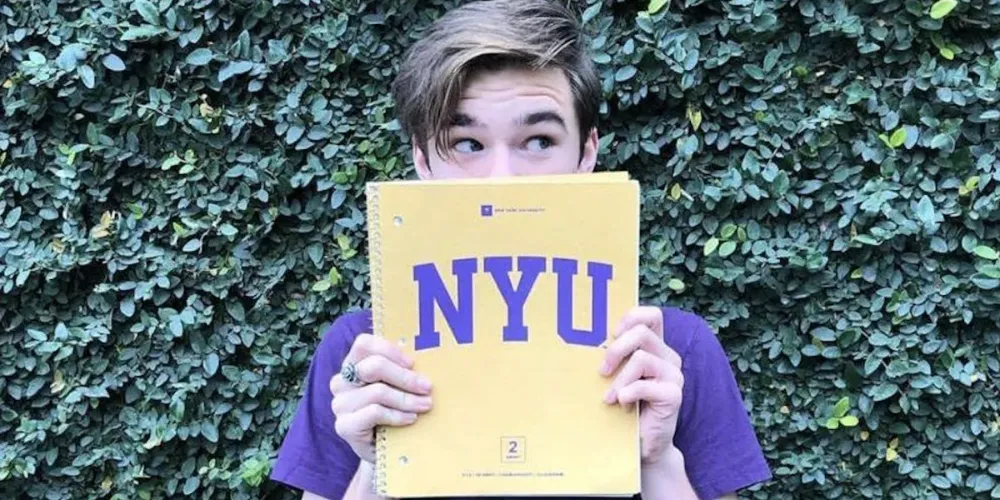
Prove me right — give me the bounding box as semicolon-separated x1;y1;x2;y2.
367;173;640;498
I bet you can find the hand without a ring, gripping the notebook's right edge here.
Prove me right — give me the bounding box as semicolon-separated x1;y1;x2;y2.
601;306;684;465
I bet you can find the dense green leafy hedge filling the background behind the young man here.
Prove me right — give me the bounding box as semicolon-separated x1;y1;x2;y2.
0;0;1000;499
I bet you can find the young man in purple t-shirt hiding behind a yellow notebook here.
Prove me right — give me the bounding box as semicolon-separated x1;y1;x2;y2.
272;0;771;500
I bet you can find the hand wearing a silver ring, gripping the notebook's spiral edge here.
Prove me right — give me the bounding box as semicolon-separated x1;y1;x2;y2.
330;334;431;462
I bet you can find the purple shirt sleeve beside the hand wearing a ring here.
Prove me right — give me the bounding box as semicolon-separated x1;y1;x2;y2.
271;317;360;499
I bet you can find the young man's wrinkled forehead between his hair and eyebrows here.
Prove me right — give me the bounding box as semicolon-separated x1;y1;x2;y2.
455;68;576;125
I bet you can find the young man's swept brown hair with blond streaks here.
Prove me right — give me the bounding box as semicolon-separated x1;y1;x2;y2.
392;0;600;158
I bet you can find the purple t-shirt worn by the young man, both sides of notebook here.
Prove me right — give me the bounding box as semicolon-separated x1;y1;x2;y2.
271;308;771;500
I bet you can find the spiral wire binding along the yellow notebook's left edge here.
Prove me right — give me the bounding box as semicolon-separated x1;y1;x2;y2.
365;183;388;497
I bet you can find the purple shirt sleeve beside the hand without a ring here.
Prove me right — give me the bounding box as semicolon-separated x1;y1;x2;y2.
664;311;772;500
